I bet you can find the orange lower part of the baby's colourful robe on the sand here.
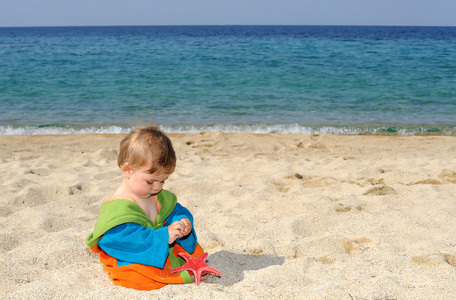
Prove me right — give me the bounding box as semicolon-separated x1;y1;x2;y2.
92;244;204;291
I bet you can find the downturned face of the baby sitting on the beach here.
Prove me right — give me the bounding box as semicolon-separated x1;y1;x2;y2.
124;167;170;199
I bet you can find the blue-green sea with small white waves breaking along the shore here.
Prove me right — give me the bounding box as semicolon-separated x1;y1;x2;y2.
0;26;456;136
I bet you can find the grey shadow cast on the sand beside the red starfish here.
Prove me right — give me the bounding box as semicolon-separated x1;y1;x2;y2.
207;250;285;286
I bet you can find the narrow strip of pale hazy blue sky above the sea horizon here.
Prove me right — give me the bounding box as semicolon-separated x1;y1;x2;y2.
0;0;456;27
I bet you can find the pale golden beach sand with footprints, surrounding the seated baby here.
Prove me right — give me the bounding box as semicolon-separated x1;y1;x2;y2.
0;133;456;299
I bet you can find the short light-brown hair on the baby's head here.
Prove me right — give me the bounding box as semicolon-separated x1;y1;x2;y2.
117;126;176;174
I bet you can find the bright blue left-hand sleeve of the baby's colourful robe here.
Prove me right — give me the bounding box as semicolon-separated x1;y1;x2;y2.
98;223;169;269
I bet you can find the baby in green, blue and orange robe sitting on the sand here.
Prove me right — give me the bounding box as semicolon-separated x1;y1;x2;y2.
86;127;204;290
